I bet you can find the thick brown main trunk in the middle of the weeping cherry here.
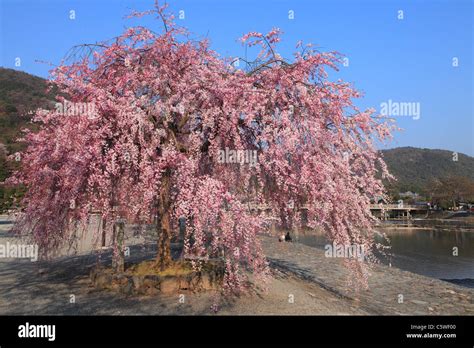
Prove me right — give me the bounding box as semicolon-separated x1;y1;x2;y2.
156;172;172;270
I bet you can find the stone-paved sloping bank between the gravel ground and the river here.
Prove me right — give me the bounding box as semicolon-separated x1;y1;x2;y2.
262;237;474;315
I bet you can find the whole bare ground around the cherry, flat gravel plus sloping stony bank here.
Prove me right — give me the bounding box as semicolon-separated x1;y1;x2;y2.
0;216;474;315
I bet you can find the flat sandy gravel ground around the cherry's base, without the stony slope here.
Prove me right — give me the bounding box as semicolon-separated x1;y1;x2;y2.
0;219;367;315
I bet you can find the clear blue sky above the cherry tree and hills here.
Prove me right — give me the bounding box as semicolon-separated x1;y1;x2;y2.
0;0;474;156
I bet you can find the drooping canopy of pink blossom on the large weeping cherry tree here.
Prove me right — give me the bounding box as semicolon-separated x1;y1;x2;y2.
6;2;391;292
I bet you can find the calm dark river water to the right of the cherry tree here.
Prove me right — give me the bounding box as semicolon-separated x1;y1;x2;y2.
298;227;474;288
